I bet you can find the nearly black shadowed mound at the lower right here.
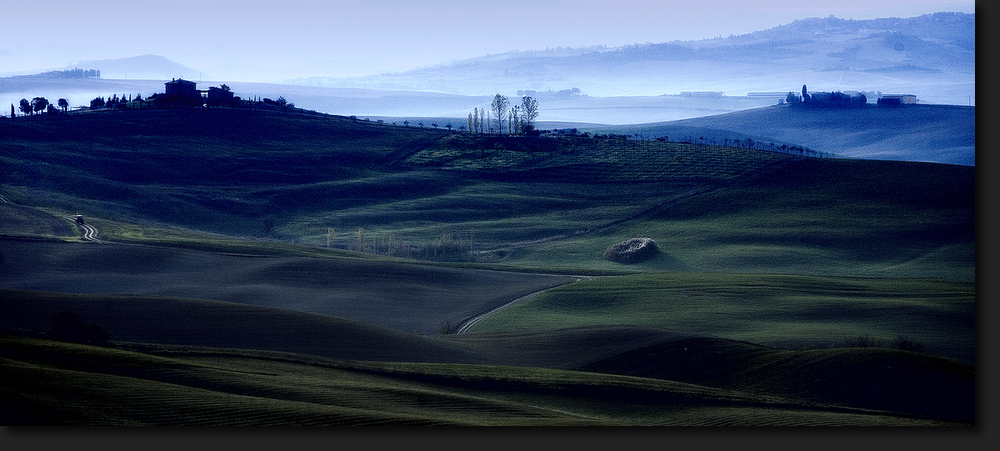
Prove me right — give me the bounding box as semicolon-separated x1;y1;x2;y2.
578;337;976;423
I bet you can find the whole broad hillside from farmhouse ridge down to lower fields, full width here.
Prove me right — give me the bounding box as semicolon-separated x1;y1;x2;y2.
0;111;975;278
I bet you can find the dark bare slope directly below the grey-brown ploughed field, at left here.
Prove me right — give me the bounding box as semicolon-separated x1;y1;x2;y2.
0;289;492;362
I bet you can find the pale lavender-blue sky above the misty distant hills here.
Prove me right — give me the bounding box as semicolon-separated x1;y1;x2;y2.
0;0;981;82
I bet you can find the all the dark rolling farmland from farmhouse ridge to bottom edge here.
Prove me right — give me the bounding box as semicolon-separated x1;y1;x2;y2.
0;110;977;425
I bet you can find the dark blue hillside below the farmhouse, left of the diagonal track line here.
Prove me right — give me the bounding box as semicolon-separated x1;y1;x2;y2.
0;110;796;251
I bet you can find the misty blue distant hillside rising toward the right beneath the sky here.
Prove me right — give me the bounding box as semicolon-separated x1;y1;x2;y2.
292;13;975;105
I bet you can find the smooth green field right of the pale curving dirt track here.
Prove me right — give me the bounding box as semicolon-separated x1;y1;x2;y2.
470;273;976;364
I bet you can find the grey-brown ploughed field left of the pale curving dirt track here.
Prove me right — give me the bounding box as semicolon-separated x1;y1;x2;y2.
0;240;574;333
